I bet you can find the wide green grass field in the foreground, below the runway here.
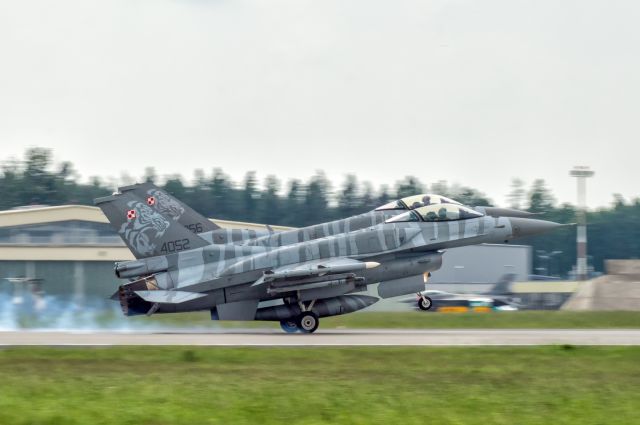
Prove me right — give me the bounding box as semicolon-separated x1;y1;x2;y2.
0;346;640;425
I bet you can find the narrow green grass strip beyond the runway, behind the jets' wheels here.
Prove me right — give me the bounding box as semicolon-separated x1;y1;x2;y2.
127;311;640;329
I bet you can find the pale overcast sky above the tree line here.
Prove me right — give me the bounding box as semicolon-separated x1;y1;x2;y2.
0;0;640;207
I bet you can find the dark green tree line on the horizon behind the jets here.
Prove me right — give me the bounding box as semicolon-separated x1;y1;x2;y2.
0;148;640;276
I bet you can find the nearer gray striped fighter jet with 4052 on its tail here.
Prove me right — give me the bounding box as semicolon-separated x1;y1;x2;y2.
96;193;562;333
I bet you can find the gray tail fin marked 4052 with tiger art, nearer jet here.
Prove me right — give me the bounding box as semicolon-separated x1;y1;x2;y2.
94;193;208;258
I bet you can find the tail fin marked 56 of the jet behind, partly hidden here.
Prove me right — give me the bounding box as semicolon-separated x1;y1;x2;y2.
118;183;220;233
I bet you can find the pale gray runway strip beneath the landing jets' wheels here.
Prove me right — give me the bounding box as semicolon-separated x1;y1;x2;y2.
0;329;640;347
